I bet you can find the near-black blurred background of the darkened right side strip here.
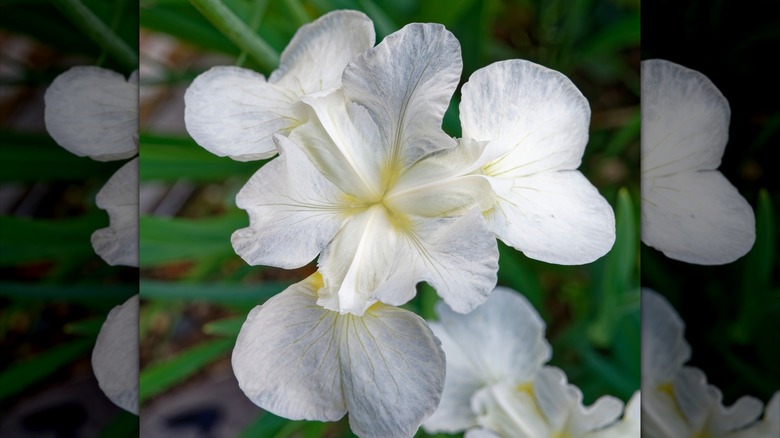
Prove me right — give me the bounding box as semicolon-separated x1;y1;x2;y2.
641;0;780;405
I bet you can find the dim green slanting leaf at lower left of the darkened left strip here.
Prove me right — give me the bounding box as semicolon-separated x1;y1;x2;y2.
0;339;95;400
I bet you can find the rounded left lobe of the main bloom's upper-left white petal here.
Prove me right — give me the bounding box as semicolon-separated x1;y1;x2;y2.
184;67;300;161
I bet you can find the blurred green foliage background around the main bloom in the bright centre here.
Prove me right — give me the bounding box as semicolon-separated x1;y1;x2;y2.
140;0;640;437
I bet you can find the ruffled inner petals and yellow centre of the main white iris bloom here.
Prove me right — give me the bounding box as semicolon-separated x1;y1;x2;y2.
232;24;498;315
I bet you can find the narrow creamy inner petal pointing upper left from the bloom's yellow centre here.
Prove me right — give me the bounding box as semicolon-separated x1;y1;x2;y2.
291;91;387;201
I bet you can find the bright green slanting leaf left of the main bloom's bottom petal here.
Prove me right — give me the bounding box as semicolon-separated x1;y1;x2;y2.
138;339;234;403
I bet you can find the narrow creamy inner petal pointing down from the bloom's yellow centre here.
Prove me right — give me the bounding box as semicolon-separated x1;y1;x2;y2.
318;205;402;315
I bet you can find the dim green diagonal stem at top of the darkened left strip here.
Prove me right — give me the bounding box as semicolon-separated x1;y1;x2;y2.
52;0;138;70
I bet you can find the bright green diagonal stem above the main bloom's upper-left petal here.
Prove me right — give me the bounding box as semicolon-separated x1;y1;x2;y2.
190;0;279;71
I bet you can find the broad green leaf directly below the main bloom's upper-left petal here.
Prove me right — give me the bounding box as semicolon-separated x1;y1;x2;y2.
139;133;258;181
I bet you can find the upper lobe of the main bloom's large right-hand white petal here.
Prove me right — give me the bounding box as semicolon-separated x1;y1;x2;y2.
460;59;590;178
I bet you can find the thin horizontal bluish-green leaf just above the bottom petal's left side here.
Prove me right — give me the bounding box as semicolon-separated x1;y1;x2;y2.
141;280;289;306
